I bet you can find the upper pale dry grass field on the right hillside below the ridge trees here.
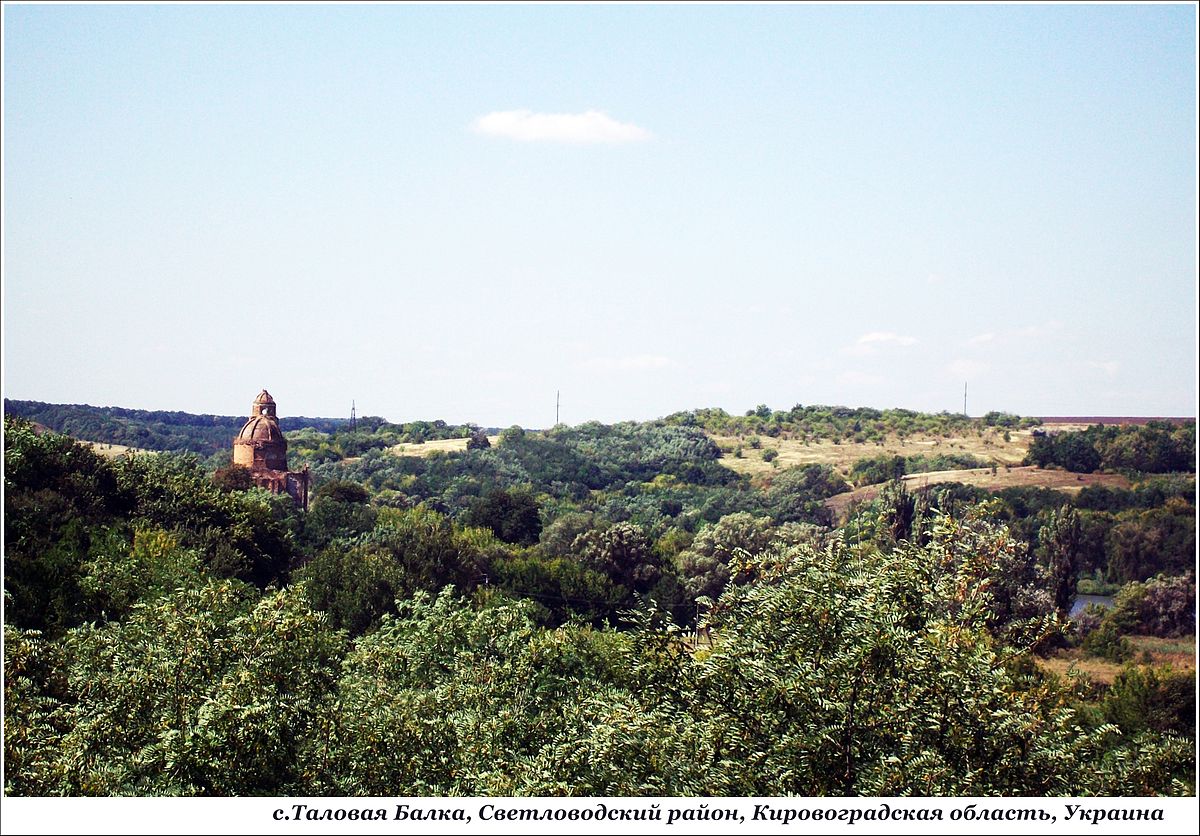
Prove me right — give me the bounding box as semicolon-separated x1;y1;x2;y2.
712;427;1032;476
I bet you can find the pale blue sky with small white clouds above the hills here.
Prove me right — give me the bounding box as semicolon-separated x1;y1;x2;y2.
4;5;1196;427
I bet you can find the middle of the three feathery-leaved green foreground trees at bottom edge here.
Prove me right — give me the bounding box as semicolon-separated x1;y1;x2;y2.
307;591;629;795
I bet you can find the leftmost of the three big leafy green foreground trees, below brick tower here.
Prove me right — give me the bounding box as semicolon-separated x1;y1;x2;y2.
25;581;344;795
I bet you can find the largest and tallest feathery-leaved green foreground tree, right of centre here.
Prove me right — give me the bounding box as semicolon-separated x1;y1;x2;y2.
690;517;1187;795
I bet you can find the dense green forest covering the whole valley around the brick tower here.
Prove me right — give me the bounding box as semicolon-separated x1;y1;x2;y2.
4;410;1195;796
